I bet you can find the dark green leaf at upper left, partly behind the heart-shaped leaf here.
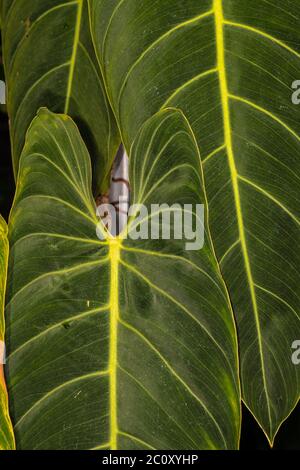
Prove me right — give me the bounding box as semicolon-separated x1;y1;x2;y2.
2;0;119;193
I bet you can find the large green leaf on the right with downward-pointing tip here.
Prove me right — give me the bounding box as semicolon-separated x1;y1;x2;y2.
89;0;300;442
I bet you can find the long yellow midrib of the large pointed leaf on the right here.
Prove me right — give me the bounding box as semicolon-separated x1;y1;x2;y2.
214;0;272;427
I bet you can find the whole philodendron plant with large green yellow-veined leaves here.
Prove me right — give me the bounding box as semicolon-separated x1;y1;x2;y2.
0;0;300;450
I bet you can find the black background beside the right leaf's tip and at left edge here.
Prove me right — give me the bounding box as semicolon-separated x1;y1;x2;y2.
0;38;300;450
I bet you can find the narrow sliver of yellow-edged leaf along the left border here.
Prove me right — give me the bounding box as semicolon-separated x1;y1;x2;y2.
0;216;15;450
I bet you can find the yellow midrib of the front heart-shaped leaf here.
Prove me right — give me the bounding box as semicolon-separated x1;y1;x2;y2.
109;238;121;450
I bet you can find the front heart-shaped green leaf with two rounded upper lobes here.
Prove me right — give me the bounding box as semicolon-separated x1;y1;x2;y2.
6;109;240;449
